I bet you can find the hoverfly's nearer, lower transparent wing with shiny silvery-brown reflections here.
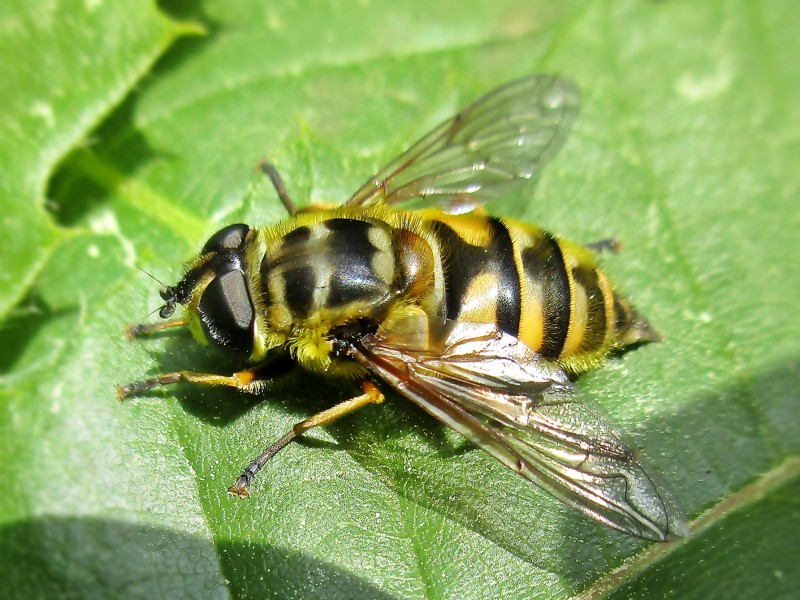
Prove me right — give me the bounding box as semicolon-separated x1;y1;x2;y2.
354;323;688;541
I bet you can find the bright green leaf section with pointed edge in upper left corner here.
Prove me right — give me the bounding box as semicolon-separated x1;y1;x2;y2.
0;0;198;315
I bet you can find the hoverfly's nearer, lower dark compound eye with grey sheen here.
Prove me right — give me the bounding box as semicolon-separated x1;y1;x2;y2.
197;271;255;356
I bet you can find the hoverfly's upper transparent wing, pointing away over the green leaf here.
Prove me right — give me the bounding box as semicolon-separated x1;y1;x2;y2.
348;75;580;211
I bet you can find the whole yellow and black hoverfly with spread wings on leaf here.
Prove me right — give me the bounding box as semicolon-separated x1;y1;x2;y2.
118;75;688;541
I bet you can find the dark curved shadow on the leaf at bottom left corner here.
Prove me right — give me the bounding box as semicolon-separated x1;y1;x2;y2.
0;517;389;599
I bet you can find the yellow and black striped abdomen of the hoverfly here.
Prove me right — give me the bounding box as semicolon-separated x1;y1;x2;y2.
421;211;627;372
